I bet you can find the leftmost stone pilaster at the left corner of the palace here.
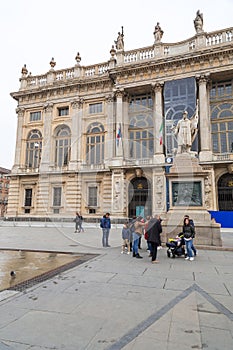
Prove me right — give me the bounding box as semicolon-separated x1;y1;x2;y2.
12;108;25;173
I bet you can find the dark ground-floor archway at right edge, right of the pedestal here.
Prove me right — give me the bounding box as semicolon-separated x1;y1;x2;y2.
218;174;233;211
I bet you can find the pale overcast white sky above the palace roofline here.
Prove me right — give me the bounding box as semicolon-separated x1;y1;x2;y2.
0;0;233;169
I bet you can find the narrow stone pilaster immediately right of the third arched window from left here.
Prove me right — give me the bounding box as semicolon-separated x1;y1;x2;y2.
104;95;116;165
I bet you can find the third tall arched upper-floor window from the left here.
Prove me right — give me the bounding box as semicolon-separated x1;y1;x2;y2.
86;122;104;164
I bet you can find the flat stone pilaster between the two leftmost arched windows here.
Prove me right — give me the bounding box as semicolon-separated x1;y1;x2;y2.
40;103;54;172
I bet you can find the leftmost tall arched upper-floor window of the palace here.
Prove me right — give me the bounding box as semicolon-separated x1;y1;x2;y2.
25;129;42;169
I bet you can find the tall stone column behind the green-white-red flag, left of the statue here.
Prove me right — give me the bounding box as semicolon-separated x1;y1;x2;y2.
153;83;165;163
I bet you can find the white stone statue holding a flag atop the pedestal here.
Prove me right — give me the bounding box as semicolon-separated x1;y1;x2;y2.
171;104;198;154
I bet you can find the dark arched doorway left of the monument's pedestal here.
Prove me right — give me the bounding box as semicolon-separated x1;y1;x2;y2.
128;177;152;217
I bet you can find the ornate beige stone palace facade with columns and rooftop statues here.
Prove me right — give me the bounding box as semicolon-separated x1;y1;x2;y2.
8;11;233;224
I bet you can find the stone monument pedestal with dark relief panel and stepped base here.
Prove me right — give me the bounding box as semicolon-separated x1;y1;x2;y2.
162;153;222;246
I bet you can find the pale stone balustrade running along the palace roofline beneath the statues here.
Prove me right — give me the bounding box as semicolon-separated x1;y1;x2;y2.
21;28;233;90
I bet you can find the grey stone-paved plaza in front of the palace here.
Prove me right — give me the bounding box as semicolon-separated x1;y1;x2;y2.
0;222;233;350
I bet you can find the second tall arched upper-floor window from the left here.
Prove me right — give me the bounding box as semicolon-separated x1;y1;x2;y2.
55;125;71;167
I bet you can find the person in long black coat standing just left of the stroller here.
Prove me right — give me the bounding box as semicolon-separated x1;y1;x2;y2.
147;215;162;264
